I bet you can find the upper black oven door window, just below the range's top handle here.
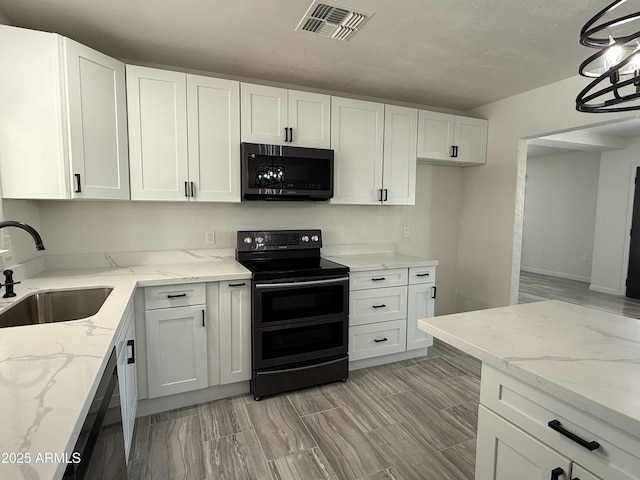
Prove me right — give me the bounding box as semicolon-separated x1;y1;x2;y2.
260;284;346;324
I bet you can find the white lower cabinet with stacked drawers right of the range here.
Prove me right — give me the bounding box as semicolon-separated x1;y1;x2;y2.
349;266;436;361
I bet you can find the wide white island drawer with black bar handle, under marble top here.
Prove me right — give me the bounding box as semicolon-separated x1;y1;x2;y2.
480;365;640;480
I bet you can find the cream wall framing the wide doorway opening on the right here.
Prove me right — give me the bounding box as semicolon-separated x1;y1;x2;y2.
457;74;628;311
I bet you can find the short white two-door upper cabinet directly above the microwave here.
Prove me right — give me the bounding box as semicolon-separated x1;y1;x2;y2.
241;83;331;148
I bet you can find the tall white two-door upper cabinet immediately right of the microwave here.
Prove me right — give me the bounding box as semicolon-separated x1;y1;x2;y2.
331;97;417;205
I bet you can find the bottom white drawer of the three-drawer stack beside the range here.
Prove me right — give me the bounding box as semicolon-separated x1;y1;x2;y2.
349;320;407;361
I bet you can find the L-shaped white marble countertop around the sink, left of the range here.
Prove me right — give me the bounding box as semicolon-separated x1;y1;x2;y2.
0;252;251;480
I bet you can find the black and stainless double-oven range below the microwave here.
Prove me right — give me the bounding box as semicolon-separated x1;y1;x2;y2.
236;230;349;400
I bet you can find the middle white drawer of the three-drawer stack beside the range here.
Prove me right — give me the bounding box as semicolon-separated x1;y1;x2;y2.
349;287;407;325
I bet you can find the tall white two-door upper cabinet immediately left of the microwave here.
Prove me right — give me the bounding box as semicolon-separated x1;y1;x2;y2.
127;65;240;202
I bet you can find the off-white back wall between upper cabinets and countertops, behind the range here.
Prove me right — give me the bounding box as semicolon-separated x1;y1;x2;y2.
4;165;463;314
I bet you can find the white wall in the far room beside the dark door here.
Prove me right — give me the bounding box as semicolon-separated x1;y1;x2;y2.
591;138;640;295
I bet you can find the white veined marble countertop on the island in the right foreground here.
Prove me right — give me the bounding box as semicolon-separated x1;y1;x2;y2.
418;300;640;438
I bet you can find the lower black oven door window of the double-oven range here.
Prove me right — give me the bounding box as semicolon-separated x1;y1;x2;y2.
260;319;345;360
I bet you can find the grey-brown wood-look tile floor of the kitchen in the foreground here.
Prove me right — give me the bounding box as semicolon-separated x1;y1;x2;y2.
129;340;480;480
